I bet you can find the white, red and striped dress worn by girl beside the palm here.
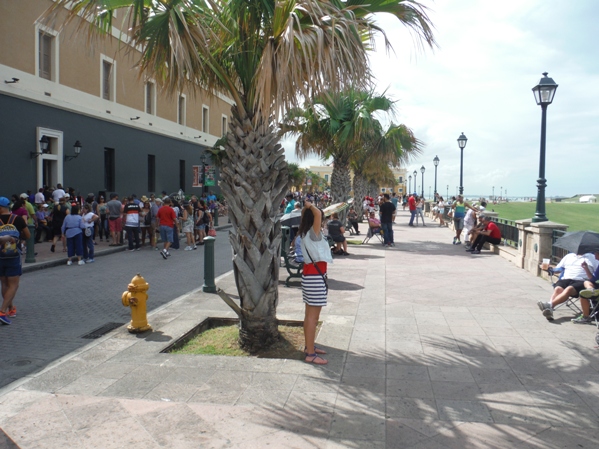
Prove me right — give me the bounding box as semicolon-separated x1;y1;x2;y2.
301;229;333;307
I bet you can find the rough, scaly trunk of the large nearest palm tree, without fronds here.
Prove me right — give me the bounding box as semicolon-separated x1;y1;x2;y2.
220;107;289;353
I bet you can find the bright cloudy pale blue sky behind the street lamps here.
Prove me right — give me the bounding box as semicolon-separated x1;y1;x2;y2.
284;0;599;197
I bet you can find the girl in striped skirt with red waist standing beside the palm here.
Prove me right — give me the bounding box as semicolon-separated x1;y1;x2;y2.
298;201;333;365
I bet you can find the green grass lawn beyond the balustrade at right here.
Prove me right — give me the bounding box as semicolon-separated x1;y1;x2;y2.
487;202;599;232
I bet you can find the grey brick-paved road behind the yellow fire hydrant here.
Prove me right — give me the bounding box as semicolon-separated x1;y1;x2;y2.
0;232;233;387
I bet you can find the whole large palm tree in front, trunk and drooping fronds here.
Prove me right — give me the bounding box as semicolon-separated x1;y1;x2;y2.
45;0;435;351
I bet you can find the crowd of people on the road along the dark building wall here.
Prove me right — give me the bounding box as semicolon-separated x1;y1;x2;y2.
0;184;225;324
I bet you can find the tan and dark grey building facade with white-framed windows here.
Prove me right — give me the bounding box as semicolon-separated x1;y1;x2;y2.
0;0;232;196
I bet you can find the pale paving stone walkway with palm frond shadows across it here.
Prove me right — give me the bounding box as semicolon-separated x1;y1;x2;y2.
0;211;599;449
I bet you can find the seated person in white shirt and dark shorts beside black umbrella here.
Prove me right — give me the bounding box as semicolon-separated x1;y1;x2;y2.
537;253;597;321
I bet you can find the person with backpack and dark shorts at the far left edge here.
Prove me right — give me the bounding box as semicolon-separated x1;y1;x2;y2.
0;196;30;324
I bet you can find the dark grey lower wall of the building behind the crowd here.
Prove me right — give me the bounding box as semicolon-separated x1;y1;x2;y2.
0;94;219;197
